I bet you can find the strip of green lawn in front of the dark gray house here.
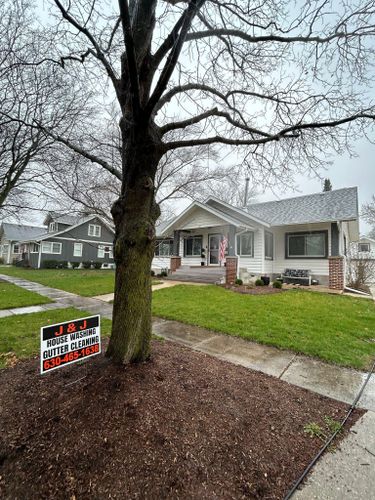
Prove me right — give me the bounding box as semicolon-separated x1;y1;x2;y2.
0;267;161;297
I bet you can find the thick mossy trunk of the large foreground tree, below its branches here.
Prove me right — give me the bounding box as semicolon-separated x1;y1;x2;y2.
106;121;162;363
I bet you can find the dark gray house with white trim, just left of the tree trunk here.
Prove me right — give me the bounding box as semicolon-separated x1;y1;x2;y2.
3;213;114;269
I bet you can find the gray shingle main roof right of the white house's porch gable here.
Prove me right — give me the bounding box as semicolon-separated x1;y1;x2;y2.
246;187;358;226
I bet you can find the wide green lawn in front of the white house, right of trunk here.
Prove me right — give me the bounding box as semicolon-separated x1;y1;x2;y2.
153;285;375;369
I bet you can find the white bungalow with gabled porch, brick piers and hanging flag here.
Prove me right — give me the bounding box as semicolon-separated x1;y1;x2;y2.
153;187;359;288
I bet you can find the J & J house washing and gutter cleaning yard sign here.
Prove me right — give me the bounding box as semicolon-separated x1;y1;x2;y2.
40;316;101;374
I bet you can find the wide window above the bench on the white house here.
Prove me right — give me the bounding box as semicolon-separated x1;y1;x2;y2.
286;231;328;259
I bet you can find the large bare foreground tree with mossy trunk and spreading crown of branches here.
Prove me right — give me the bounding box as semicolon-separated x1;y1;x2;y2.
3;0;375;363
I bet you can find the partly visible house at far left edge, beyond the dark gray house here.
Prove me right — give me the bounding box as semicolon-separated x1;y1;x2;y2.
0;222;45;264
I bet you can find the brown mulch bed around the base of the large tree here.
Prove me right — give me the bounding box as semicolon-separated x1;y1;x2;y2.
0;341;363;500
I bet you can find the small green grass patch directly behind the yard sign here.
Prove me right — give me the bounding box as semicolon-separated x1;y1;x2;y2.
0;308;111;368
